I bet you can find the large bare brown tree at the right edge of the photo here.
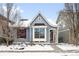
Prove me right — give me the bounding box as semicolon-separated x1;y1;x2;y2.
60;3;79;45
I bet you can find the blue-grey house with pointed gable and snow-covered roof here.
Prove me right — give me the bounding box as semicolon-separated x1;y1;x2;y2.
10;12;58;44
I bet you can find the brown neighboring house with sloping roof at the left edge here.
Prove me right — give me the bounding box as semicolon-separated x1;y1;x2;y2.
0;15;13;37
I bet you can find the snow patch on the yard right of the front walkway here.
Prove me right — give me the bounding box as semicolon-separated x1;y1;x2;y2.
56;44;79;51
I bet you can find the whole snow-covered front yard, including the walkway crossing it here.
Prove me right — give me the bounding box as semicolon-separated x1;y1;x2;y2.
0;43;79;52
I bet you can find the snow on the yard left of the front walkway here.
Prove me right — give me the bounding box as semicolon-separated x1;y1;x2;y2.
0;45;54;51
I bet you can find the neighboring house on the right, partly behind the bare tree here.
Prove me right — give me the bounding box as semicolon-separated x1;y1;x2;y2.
56;13;70;43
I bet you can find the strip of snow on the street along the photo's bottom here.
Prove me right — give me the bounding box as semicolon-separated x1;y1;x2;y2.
0;52;79;56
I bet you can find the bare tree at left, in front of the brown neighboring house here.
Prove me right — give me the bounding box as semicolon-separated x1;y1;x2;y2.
1;3;20;46
